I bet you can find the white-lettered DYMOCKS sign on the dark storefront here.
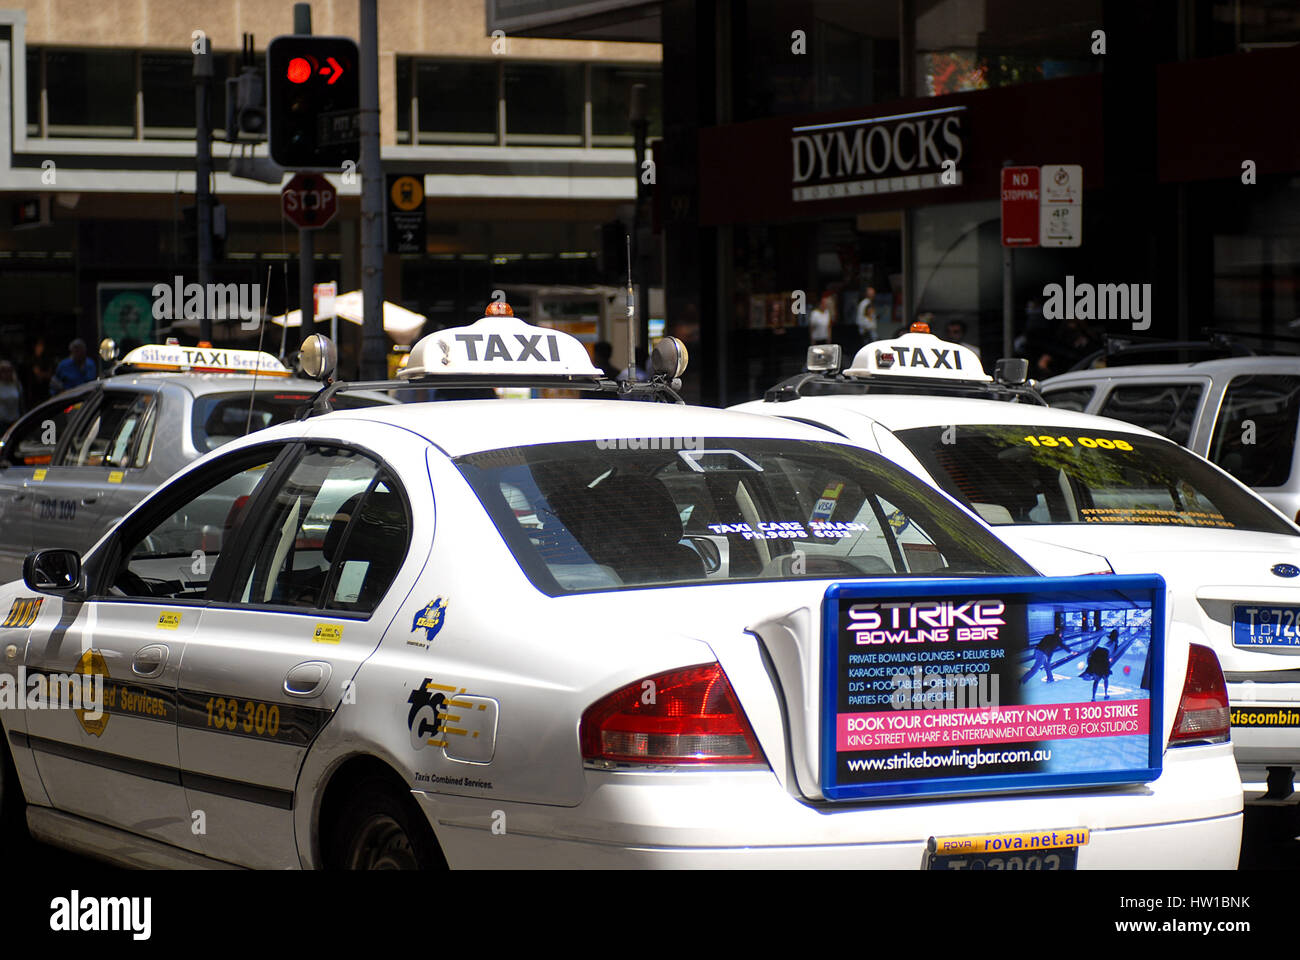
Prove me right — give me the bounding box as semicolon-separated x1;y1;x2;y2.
790;107;966;202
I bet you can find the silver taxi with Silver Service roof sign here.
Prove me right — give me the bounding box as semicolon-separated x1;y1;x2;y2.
0;343;393;581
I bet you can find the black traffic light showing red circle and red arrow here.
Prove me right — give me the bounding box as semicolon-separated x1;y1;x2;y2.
267;35;361;170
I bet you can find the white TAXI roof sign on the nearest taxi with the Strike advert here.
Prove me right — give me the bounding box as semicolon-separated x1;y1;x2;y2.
398;310;605;380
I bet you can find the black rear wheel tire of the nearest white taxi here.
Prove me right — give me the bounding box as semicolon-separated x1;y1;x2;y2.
329;777;447;870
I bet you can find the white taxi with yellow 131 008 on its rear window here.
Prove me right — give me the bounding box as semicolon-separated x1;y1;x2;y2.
735;332;1300;801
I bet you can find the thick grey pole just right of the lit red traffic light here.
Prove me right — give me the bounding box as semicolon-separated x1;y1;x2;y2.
359;0;387;380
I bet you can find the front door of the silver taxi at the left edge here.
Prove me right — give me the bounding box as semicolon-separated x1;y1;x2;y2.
0;386;98;583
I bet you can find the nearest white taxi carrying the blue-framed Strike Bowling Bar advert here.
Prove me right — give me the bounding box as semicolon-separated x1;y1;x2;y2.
0;306;1242;869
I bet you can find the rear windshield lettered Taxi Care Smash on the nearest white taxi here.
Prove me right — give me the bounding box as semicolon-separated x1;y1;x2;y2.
456;437;1034;596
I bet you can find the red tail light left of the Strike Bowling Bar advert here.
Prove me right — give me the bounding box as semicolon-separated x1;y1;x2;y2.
579;663;764;764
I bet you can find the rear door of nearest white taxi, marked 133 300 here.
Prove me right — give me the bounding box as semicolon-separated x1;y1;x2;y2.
172;424;432;868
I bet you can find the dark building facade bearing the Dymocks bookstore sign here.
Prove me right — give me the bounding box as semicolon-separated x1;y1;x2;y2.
499;0;1300;403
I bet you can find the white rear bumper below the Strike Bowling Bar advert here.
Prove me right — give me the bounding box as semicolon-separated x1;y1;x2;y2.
415;744;1242;870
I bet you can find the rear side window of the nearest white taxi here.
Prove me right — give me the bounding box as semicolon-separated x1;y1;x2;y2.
233;446;411;613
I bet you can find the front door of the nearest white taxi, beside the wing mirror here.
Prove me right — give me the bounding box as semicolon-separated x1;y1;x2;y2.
25;444;285;851
